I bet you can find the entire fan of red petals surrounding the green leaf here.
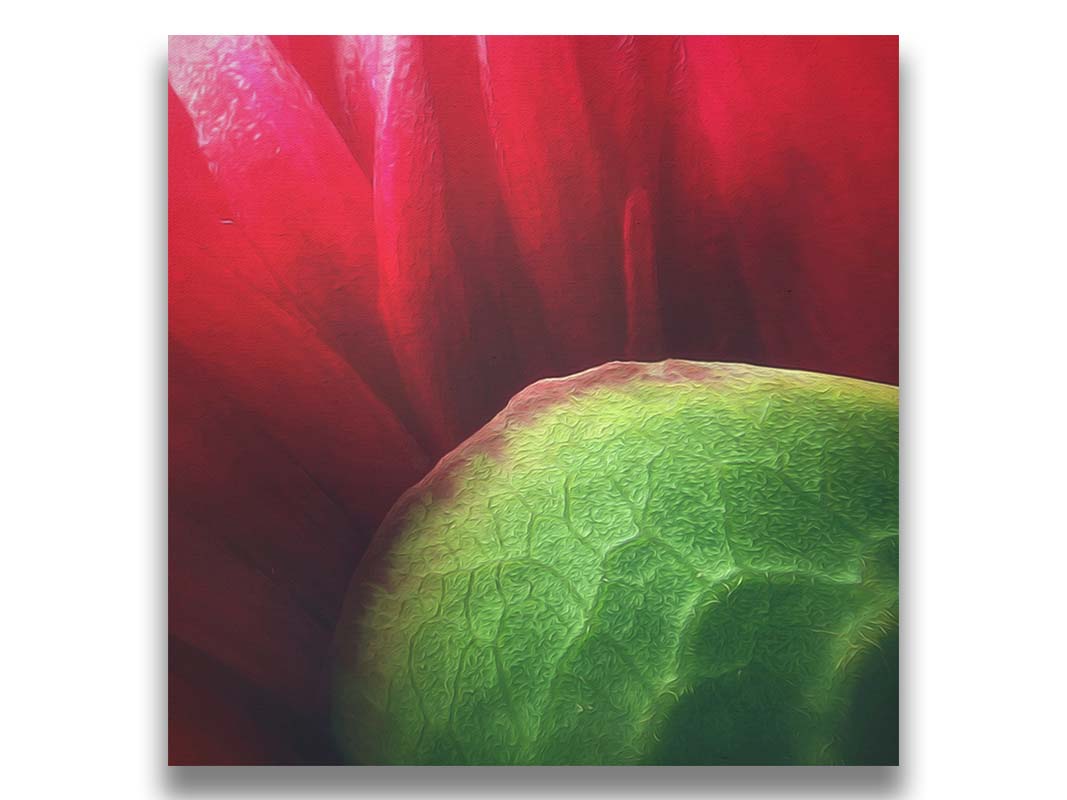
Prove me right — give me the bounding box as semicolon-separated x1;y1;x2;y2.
170;36;897;764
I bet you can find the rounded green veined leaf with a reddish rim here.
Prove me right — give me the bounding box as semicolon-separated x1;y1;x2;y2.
334;361;897;764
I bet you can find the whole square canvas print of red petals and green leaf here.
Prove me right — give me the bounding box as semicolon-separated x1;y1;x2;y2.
168;35;898;765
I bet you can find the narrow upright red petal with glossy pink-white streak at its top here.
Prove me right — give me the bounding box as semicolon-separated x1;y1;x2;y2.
343;36;484;454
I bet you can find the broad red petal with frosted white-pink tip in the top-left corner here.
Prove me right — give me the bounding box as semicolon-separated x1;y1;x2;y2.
171;36;404;415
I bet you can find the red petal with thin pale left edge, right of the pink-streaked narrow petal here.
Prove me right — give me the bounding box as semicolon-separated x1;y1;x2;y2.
480;36;625;373
